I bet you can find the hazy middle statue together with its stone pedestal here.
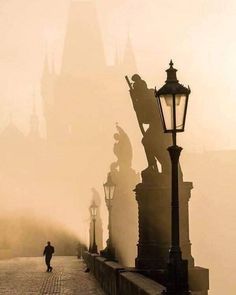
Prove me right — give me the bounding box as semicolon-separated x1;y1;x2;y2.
107;124;140;267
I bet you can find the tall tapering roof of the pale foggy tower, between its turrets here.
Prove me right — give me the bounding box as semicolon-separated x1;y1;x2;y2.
61;1;106;77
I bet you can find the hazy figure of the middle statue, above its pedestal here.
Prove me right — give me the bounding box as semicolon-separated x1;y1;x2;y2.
111;124;133;171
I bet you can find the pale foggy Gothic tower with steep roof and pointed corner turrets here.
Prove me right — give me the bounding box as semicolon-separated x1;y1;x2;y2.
41;1;136;144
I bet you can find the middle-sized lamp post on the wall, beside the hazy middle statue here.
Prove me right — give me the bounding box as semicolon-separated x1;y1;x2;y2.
102;173;116;259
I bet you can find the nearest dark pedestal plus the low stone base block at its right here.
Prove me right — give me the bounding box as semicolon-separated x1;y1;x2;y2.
135;172;209;295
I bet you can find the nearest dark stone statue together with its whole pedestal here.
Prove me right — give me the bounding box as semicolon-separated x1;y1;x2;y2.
126;74;209;295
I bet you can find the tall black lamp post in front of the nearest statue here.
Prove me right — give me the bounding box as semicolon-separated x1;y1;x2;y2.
155;60;190;295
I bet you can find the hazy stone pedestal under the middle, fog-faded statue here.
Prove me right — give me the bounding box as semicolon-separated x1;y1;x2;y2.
111;169;140;267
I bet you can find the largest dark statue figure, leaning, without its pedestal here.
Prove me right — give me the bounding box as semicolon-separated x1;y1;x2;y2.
125;74;171;178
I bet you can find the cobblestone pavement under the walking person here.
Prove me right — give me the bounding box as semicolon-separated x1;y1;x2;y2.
0;256;105;295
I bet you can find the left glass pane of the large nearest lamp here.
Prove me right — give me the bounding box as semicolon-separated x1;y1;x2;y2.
159;94;174;130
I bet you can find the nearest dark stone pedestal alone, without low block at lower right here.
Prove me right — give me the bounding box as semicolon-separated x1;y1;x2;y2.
135;175;194;269
